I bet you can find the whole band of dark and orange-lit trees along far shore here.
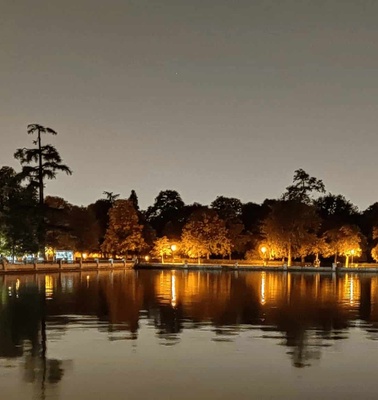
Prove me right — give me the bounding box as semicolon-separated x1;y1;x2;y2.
0;124;378;265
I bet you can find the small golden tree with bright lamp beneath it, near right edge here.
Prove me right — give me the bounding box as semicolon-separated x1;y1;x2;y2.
324;225;364;266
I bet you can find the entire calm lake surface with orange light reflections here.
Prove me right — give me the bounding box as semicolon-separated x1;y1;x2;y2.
0;271;378;400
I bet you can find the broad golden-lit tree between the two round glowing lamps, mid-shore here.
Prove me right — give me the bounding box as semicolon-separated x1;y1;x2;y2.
181;208;231;259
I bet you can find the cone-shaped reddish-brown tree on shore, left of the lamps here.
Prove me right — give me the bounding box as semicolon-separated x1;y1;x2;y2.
101;199;145;256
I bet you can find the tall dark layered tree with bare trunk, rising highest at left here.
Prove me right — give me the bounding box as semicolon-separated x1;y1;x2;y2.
14;124;72;255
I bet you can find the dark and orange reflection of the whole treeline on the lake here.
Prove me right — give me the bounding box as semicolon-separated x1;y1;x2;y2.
0;271;378;374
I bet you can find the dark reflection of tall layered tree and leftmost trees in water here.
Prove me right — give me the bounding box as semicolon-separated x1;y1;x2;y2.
0;285;69;399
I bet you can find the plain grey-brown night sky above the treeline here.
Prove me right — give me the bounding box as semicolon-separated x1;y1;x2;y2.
0;0;378;209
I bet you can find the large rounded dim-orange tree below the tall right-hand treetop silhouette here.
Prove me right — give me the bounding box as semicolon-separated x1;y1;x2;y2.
261;200;320;266
